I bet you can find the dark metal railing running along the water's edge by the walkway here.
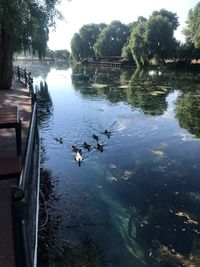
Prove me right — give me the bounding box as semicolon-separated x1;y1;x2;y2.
12;67;40;267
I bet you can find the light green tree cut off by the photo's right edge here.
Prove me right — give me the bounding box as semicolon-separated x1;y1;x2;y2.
184;2;200;48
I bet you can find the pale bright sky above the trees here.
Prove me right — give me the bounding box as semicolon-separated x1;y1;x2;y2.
48;0;200;51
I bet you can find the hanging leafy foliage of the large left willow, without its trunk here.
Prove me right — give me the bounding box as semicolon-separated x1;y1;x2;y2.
0;0;59;58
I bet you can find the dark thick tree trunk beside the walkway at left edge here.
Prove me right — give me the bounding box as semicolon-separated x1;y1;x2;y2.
0;25;13;90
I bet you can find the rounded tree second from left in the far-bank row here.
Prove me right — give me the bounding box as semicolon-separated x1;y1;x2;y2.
94;21;130;57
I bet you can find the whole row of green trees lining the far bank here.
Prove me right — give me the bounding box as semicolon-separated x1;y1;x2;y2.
71;2;200;67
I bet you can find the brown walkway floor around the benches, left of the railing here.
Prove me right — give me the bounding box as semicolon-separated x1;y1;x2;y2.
0;81;31;267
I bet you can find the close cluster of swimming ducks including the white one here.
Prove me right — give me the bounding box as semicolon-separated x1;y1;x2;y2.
72;130;111;166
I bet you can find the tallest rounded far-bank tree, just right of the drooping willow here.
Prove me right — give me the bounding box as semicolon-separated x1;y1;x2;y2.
146;9;179;62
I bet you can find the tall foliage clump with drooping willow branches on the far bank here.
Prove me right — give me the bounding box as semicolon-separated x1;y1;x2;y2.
130;9;178;67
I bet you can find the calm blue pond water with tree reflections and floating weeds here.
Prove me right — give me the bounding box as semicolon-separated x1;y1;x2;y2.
17;61;200;267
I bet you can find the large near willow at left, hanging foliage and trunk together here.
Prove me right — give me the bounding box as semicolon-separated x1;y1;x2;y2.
0;0;60;90
